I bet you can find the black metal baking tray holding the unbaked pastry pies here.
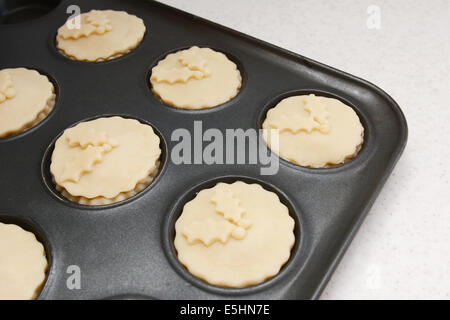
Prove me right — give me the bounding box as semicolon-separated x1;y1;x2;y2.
0;0;407;299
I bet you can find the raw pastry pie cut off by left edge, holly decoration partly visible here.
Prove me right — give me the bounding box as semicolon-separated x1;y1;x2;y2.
0;68;55;138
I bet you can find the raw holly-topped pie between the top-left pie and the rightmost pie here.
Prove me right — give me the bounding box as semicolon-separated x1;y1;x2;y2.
150;47;242;109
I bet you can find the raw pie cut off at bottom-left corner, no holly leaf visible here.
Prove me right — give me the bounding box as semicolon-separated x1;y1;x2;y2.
0;222;48;300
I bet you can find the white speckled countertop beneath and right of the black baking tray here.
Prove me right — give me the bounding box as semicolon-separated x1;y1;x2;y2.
161;0;450;299
